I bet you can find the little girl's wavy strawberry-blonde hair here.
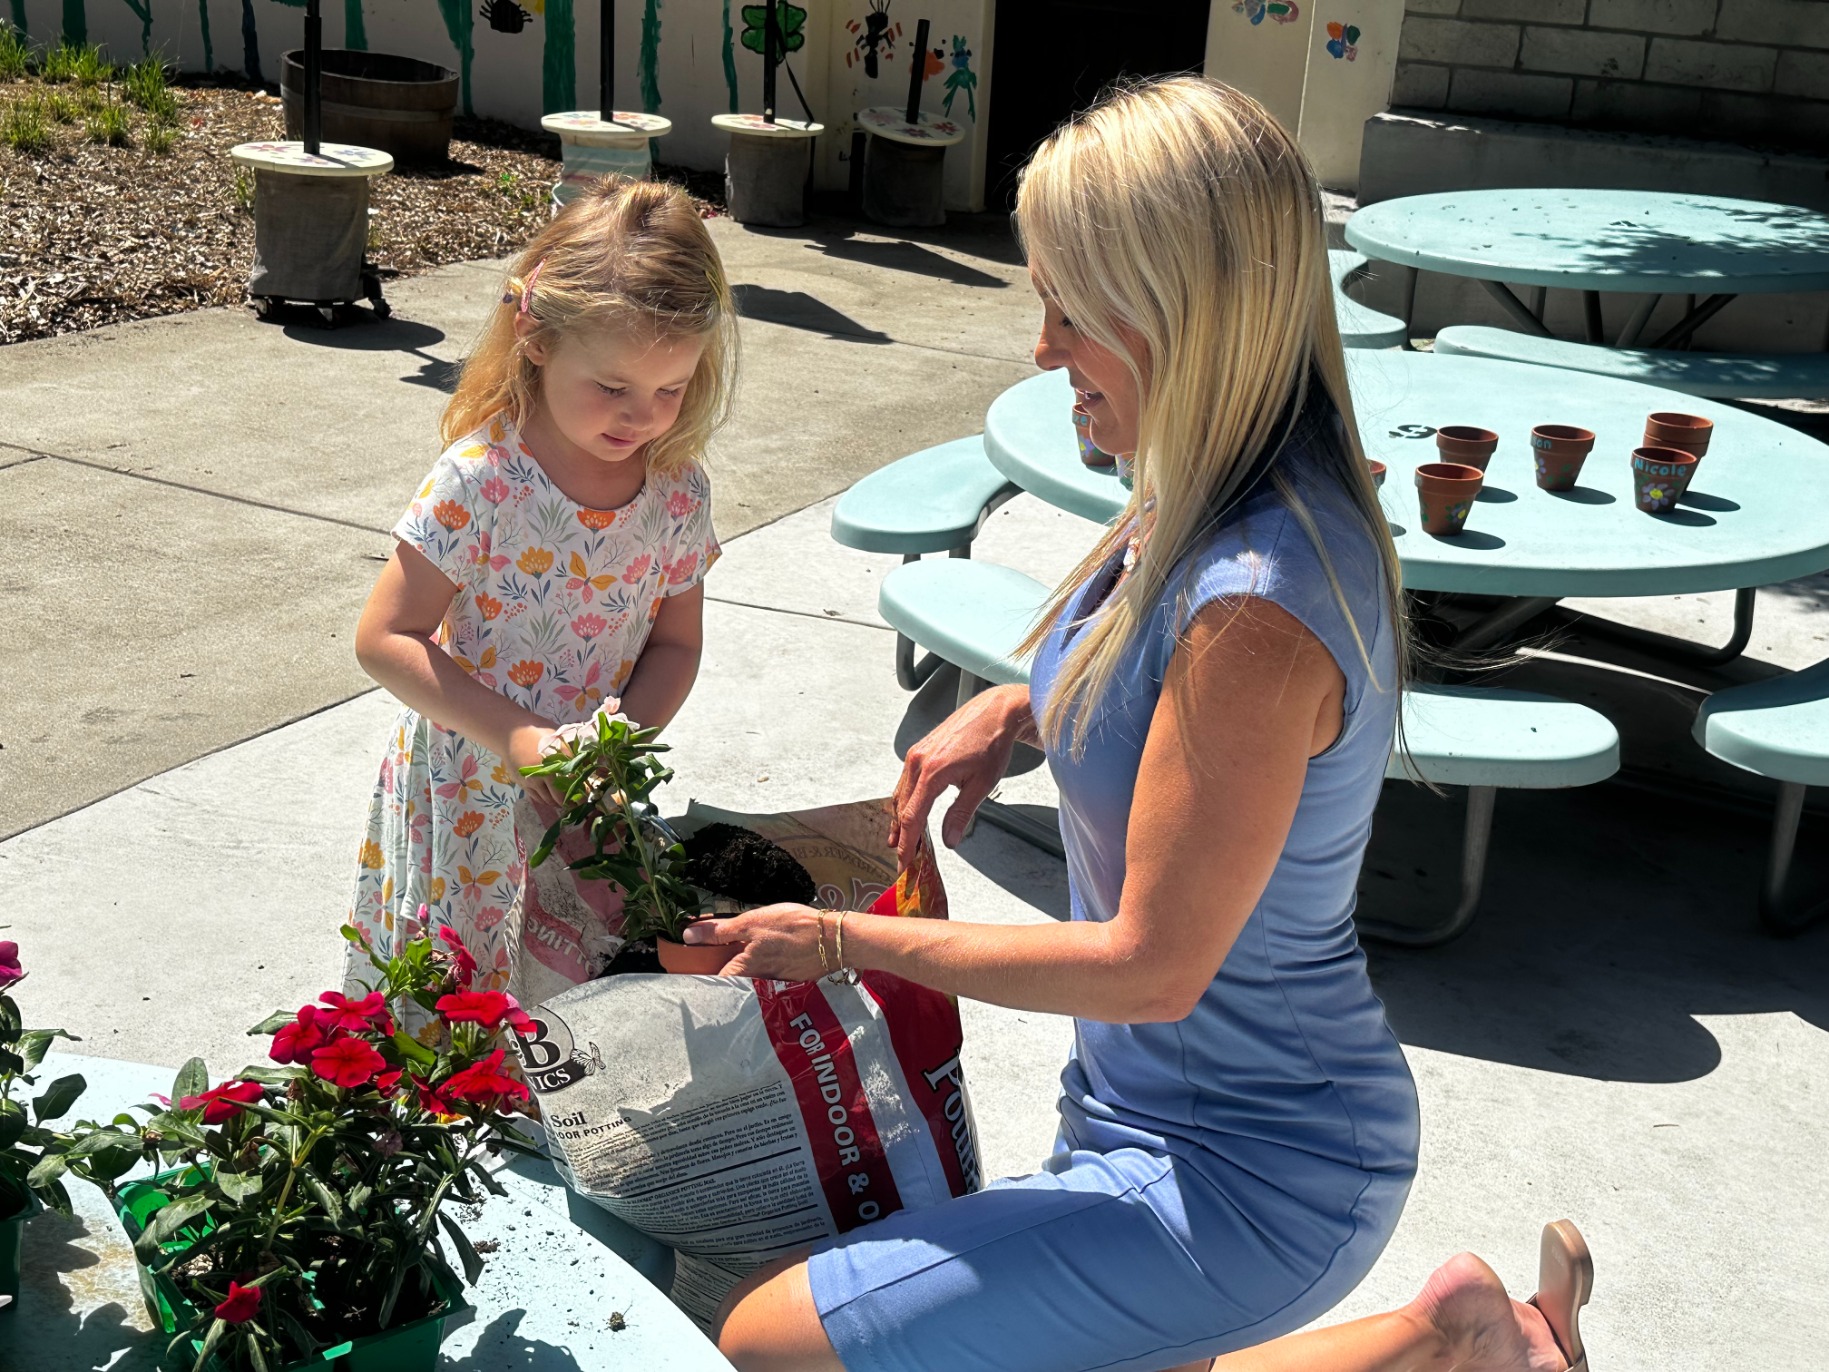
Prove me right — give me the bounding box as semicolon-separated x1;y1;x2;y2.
439;176;737;476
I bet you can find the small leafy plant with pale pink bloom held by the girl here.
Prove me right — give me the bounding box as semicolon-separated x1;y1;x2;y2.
521;715;704;942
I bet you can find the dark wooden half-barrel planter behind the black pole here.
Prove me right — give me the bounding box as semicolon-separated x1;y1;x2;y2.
280;48;457;163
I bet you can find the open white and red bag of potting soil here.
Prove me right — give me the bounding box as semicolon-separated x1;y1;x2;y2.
519;801;980;1324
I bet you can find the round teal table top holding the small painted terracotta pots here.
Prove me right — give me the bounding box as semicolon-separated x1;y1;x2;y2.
984;349;1829;598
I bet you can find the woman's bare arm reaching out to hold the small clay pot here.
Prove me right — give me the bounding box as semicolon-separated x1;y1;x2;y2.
688;598;1344;1023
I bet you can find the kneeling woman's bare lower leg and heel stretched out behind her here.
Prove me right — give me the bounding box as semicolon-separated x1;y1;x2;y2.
1174;1253;1569;1372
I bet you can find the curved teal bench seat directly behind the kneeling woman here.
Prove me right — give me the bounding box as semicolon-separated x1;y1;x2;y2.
878;562;1619;948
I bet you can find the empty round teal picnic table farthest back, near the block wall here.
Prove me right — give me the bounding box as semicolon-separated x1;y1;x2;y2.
1346;188;1829;349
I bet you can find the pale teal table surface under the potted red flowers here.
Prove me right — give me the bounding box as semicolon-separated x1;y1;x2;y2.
0;1054;732;1372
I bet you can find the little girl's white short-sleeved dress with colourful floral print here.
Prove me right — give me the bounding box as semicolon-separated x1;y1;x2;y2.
348;417;719;999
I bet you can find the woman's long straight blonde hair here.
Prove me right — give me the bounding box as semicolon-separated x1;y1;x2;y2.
1017;77;1408;752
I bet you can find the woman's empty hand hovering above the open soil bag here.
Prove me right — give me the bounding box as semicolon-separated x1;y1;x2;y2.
889;686;1030;867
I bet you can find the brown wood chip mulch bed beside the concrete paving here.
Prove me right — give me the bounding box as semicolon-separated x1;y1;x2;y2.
0;79;717;344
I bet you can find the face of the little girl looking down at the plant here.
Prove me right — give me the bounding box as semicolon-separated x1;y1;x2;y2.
527;329;706;463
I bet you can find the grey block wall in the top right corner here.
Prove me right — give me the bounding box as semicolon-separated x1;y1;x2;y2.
1390;0;1829;152
